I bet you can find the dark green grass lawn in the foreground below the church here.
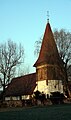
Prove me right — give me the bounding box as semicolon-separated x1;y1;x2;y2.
0;104;71;120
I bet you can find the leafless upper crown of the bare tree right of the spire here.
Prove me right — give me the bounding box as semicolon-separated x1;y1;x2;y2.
54;29;71;68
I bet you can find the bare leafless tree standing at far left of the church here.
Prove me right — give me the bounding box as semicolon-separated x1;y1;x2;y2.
0;40;24;91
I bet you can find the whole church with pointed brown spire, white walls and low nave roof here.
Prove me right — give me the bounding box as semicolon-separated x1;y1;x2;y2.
5;21;65;99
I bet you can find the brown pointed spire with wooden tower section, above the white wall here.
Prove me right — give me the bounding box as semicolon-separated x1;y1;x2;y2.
34;22;64;81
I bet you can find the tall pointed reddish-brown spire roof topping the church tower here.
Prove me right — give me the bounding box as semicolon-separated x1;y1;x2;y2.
34;23;61;67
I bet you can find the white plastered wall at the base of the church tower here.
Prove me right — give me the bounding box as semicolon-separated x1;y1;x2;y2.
34;80;63;95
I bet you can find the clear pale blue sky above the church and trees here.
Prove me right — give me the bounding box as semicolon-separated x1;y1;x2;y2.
0;0;71;72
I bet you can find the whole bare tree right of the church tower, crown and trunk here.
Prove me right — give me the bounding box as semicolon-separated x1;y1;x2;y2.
54;29;71;96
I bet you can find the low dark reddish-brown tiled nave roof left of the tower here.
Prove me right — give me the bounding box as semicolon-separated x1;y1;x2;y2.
5;73;36;96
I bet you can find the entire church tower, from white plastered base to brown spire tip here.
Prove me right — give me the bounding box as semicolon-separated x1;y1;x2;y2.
34;22;64;94
